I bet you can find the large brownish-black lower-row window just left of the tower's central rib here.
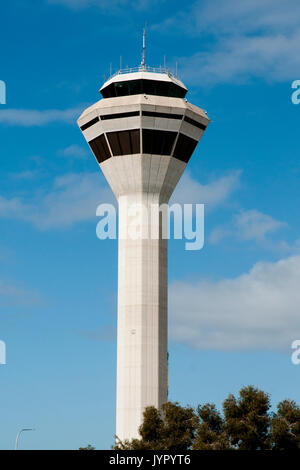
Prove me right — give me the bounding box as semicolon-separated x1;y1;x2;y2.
106;129;140;156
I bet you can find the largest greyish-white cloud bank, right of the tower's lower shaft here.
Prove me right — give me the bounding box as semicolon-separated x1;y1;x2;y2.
169;256;300;352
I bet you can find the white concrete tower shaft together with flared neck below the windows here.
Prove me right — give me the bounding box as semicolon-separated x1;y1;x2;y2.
101;154;186;440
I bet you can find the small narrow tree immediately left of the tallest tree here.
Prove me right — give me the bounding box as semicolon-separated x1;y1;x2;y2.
193;403;230;450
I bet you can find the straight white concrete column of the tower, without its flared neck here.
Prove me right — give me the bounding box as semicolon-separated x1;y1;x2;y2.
116;193;168;440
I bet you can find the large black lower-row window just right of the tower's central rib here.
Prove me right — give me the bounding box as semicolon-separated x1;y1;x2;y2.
143;129;177;155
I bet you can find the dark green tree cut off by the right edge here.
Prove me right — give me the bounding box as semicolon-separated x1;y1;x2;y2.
271;400;300;450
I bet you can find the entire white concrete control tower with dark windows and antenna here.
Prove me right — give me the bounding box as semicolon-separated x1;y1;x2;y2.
78;42;209;440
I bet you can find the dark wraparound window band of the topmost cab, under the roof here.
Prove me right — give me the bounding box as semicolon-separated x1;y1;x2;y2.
101;79;186;98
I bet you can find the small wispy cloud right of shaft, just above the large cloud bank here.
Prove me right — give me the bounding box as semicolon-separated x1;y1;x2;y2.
210;209;287;243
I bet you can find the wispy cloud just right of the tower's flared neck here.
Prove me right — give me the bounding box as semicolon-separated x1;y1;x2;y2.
170;170;241;209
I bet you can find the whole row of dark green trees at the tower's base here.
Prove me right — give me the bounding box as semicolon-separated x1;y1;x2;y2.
114;386;300;452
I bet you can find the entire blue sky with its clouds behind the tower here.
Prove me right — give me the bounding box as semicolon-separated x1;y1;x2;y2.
0;0;300;449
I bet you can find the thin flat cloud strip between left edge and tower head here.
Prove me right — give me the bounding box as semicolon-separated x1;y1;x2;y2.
0;108;82;127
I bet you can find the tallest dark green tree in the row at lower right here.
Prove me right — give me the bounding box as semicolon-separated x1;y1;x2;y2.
223;385;271;450
